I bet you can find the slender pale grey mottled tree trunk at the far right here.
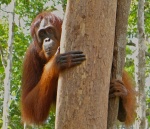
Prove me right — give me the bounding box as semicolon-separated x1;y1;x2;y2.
135;0;147;129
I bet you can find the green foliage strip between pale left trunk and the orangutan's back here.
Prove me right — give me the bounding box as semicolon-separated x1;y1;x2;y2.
10;26;29;129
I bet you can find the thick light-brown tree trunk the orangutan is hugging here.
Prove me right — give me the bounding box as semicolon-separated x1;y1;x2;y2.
55;0;117;129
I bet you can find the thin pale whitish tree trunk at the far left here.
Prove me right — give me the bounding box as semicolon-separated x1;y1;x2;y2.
2;0;15;129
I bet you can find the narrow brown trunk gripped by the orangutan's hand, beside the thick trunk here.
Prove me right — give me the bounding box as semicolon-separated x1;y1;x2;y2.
107;0;131;129
